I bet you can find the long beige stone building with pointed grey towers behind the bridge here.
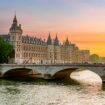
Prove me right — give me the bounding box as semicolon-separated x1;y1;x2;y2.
1;15;90;64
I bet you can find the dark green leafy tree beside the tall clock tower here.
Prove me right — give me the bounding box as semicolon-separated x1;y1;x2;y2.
0;37;13;63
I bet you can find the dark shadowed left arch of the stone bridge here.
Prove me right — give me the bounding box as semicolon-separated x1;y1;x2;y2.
2;68;36;77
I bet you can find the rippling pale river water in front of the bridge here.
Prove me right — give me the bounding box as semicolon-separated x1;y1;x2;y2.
0;79;105;105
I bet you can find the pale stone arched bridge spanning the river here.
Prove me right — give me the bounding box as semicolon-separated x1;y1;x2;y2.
0;64;105;79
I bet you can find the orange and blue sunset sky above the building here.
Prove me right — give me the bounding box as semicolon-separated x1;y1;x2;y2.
0;0;105;56
